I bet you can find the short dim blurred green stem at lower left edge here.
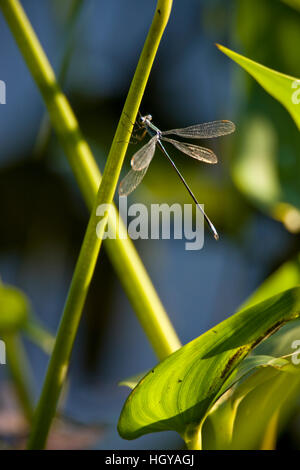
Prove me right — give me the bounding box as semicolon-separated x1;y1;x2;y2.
3;333;33;423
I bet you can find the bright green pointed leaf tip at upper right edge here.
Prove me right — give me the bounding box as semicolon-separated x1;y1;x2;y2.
217;44;300;129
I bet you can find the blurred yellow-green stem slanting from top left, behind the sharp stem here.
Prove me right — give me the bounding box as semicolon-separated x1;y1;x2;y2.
0;0;180;359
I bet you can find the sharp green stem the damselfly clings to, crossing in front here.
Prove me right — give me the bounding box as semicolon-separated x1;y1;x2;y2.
0;0;178;449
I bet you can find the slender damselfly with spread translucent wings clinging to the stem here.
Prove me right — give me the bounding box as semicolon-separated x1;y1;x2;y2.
119;114;235;240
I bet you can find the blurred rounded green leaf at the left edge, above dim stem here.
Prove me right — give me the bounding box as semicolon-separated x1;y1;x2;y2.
0;284;30;335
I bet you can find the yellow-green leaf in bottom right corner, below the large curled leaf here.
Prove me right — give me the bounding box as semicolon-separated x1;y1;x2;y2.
209;367;300;449
